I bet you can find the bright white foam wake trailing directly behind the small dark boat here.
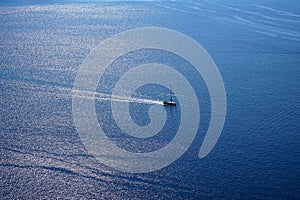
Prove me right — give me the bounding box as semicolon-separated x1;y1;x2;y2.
72;90;163;105
